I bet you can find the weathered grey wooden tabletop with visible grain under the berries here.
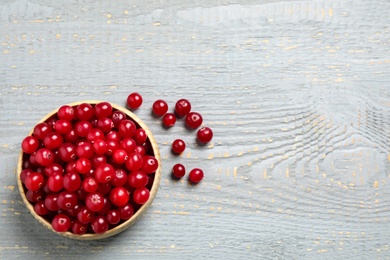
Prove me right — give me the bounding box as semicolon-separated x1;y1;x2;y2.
0;0;390;259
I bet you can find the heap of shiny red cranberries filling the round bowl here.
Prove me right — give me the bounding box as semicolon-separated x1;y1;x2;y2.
20;102;159;235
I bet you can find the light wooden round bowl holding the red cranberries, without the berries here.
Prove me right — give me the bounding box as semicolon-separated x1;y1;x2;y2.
17;100;161;240
